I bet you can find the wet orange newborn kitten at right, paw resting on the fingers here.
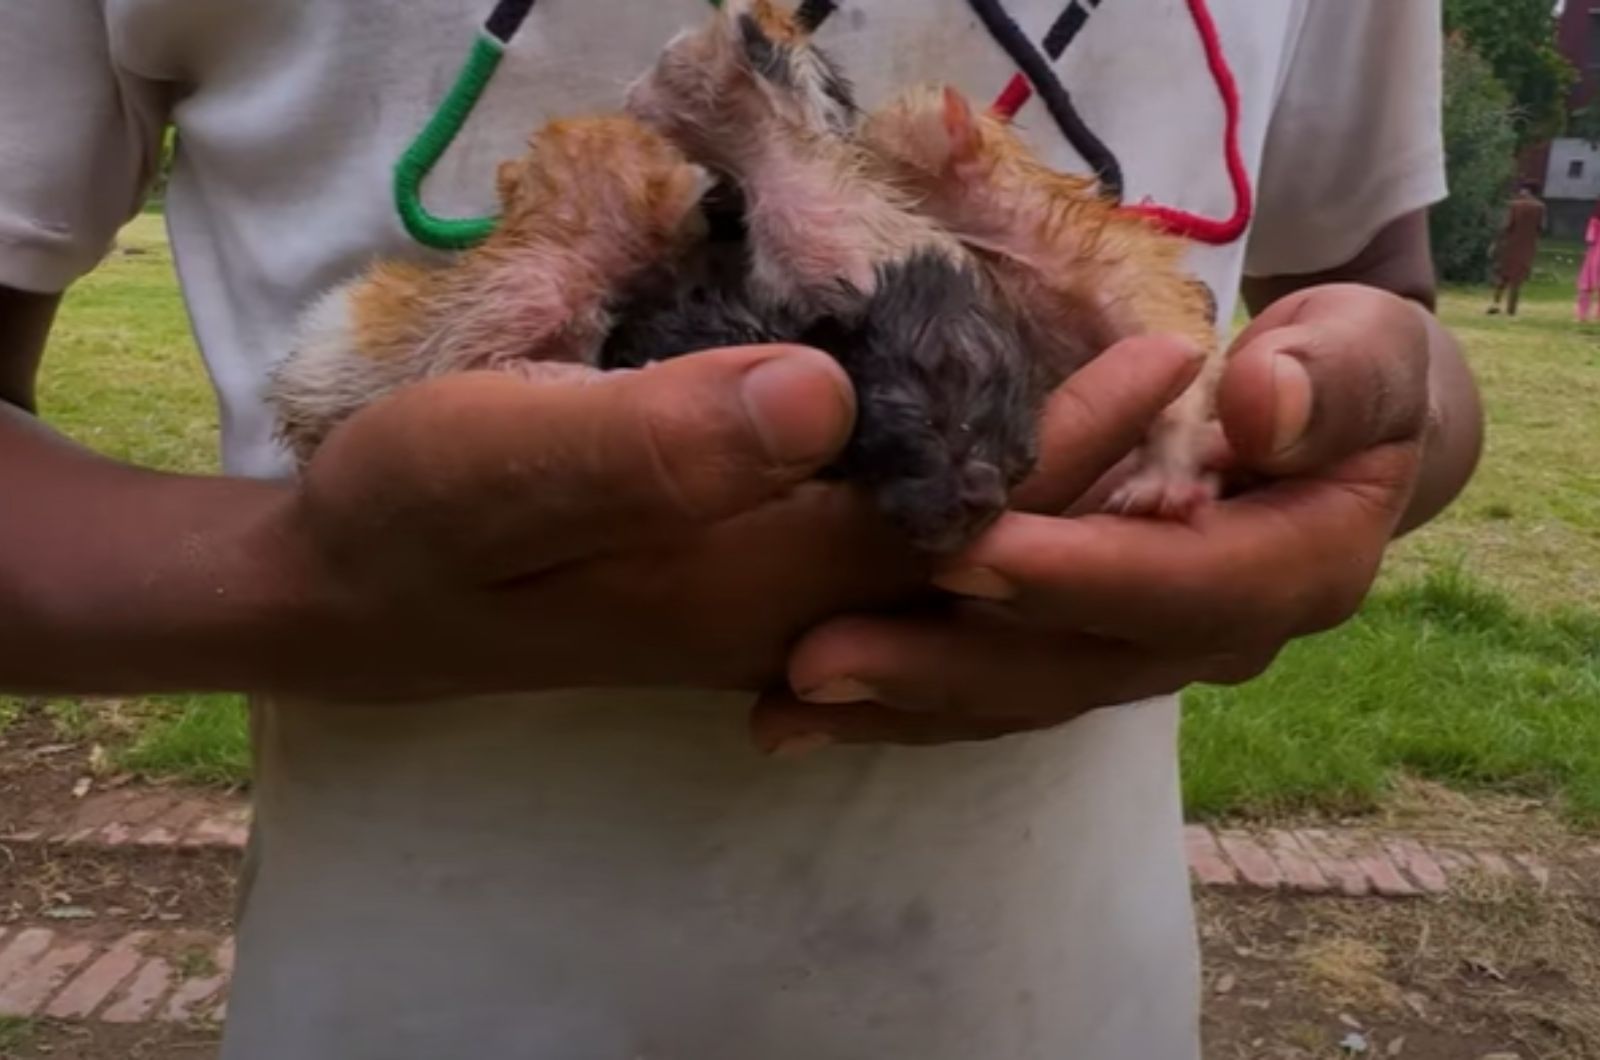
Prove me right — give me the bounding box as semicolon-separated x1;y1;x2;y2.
862;88;1222;516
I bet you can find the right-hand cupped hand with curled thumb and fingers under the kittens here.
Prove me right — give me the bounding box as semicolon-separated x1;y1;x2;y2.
754;285;1475;749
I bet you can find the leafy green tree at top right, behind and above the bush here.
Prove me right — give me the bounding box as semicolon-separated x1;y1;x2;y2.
1446;0;1578;146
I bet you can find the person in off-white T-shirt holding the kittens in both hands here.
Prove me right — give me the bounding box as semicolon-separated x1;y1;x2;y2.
0;0;1480;1060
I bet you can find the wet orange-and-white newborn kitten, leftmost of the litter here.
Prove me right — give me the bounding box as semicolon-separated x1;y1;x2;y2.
267;117;709;463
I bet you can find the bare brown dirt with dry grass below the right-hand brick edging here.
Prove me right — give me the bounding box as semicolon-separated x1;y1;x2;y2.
1198;877;1600;1060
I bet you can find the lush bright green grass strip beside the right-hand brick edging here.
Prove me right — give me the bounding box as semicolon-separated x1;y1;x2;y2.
1182;572;1600;823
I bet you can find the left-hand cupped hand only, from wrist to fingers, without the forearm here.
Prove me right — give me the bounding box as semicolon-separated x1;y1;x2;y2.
278;347;928;700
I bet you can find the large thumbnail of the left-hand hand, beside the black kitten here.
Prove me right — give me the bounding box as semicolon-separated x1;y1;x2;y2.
739;349;854;464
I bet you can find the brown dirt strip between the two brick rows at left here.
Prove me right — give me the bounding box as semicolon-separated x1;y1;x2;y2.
0;844;238;938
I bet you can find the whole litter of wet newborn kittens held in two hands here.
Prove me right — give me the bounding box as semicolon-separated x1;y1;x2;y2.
269;0;1222;552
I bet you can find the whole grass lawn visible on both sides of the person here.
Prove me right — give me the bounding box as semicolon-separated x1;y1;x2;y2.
9;215;1600;825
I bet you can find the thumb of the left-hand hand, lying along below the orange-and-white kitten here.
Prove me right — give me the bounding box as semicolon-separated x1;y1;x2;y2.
297;346;854;580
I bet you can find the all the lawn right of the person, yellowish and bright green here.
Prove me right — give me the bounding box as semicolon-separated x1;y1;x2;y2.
1182;243;1600;825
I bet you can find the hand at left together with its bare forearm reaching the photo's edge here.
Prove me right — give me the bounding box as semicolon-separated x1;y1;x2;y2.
0;347;928;700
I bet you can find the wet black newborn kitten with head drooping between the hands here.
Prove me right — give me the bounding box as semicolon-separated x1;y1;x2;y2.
602;255;1042;552
